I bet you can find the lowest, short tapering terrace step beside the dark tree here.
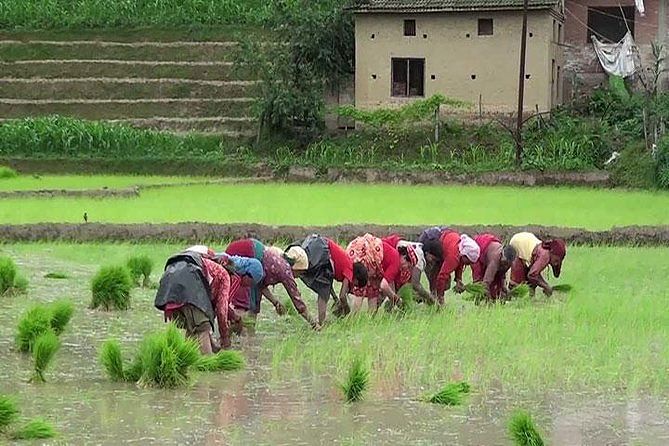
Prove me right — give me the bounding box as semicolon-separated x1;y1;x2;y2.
110;117;257;136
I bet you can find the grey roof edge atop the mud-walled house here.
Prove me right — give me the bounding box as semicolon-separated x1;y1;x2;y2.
351;0;559;12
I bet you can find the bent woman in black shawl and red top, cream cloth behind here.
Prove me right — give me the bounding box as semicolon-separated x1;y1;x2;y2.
284;234;367;325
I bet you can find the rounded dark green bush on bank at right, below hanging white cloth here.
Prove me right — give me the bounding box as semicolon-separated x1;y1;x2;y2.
611;143;656;189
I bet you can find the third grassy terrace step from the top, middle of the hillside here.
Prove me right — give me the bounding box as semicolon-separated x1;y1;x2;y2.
0;78;256;99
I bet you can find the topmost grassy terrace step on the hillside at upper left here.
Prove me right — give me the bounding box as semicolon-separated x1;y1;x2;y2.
0;40;237;62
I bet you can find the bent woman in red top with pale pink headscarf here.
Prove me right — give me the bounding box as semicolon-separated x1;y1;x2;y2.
423;229;481;305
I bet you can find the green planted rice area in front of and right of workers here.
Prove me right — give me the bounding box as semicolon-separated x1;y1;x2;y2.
268;247;669;393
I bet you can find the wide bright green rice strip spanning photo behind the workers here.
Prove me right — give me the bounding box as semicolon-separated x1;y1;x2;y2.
0;184;669;229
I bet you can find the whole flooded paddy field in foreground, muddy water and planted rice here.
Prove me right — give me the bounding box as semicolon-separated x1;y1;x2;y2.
0;243;669;445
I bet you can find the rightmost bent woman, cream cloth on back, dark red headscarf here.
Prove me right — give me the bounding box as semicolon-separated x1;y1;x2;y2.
509;232;567;296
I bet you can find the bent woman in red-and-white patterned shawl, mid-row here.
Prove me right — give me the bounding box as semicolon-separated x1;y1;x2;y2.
346;234;400;313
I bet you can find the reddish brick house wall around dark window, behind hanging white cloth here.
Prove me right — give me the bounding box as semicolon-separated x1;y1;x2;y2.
564;0;669;100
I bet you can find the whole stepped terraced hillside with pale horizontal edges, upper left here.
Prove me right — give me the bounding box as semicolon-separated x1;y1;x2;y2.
0;32;254;135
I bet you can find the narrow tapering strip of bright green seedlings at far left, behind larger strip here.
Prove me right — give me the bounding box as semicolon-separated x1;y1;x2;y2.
0;175;204;191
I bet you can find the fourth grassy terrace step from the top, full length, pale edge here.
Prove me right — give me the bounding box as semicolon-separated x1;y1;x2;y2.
0;98;253;120
